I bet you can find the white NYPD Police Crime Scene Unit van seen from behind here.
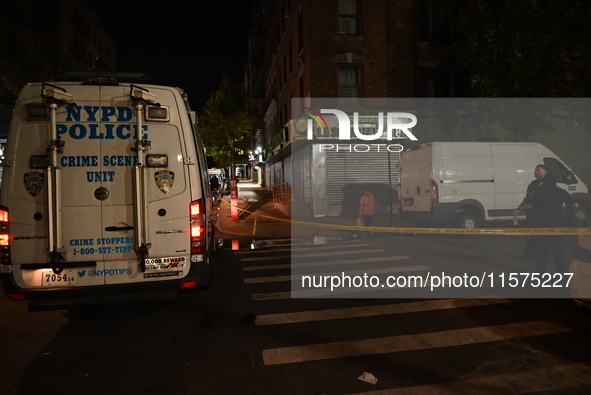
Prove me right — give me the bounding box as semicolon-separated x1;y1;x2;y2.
0;78;214;310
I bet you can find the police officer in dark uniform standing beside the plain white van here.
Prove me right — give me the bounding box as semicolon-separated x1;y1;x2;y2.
523;173;579;273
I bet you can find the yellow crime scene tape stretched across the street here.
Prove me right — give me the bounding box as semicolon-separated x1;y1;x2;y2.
220;199;591;236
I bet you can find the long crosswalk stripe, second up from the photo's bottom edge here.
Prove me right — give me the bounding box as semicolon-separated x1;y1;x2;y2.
263;321;571;365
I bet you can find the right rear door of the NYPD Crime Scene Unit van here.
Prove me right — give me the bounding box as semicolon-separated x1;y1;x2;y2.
95;86;191;284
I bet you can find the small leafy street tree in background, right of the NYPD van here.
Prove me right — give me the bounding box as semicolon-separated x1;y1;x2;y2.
197;74;261;167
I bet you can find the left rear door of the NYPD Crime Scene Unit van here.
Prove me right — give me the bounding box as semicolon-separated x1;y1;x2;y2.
3;84;104;288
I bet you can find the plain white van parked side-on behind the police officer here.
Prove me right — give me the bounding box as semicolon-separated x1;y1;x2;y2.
398;142;591;228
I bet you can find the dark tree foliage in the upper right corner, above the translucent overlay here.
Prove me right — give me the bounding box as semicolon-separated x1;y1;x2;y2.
458;0;591;98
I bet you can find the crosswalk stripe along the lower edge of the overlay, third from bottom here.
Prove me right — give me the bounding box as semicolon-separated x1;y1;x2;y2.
255;297;511;325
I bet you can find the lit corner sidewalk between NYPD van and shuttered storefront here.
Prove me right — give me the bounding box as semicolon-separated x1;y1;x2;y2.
215;182;412;239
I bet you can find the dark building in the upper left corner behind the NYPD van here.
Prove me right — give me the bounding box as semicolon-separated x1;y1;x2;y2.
0;0;116;136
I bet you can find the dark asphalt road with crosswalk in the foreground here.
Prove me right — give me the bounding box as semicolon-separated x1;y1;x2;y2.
0;235;591;394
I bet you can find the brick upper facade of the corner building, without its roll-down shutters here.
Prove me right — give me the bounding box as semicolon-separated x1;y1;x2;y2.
246;0;468;217
